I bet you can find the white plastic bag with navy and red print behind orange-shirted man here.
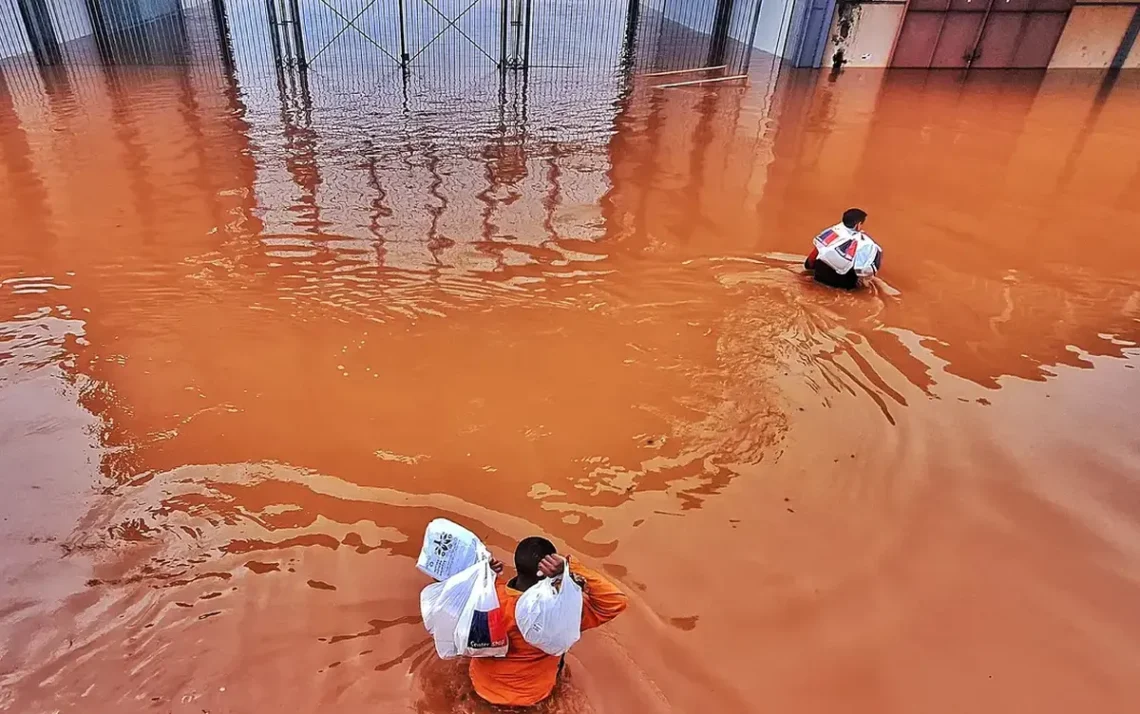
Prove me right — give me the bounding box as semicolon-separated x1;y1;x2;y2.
420;557;507;659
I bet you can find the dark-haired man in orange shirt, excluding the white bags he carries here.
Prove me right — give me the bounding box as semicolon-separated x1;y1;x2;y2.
470;536;628;706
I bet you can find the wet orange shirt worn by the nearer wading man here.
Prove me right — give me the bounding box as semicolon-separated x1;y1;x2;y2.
470;559;628;706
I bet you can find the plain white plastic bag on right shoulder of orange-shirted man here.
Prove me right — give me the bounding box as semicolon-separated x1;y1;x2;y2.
514;558;581;657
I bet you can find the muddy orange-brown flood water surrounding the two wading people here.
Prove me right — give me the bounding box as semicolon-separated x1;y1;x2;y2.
0;62;1140;714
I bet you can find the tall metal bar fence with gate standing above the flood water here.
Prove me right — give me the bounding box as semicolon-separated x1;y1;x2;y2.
0;0;760;84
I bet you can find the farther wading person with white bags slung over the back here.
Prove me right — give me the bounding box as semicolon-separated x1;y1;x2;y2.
804;209;882;290
